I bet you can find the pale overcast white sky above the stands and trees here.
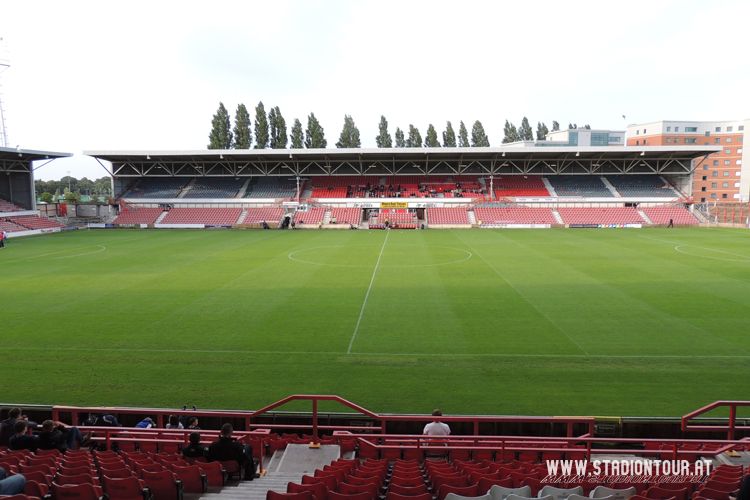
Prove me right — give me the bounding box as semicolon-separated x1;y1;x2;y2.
0;0;750;179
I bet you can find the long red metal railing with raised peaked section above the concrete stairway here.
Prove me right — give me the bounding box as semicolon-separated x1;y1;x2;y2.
52;394;595;442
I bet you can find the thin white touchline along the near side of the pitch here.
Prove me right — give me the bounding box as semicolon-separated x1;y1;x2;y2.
5;346;750;359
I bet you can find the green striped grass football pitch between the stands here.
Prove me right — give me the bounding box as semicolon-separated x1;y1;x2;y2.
0;229;750;416
